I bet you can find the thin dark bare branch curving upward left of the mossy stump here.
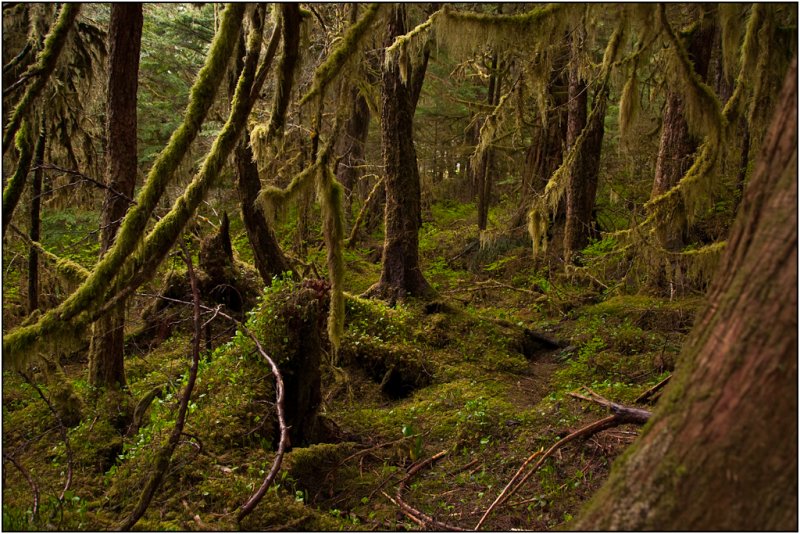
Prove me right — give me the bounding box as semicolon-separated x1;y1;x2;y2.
119;241;202;530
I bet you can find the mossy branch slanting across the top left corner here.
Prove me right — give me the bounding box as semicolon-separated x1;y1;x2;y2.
3;3;81;155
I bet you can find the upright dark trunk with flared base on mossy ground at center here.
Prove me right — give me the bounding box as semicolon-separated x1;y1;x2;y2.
367;5;433;301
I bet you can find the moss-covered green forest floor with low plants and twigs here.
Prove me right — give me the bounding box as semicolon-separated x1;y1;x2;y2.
3;202;702;531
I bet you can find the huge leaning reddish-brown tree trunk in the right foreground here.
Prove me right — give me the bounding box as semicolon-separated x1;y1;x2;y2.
576;57;798;531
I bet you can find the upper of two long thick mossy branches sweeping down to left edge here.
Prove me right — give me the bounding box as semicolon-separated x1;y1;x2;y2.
3;4;245;363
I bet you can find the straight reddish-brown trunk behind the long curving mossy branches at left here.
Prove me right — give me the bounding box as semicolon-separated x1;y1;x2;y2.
89;3;142;389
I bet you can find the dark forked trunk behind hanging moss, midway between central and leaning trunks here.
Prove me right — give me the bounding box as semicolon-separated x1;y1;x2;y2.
564;27;608;263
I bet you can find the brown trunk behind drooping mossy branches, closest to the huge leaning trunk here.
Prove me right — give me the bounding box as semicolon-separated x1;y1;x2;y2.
650;7;715;251
